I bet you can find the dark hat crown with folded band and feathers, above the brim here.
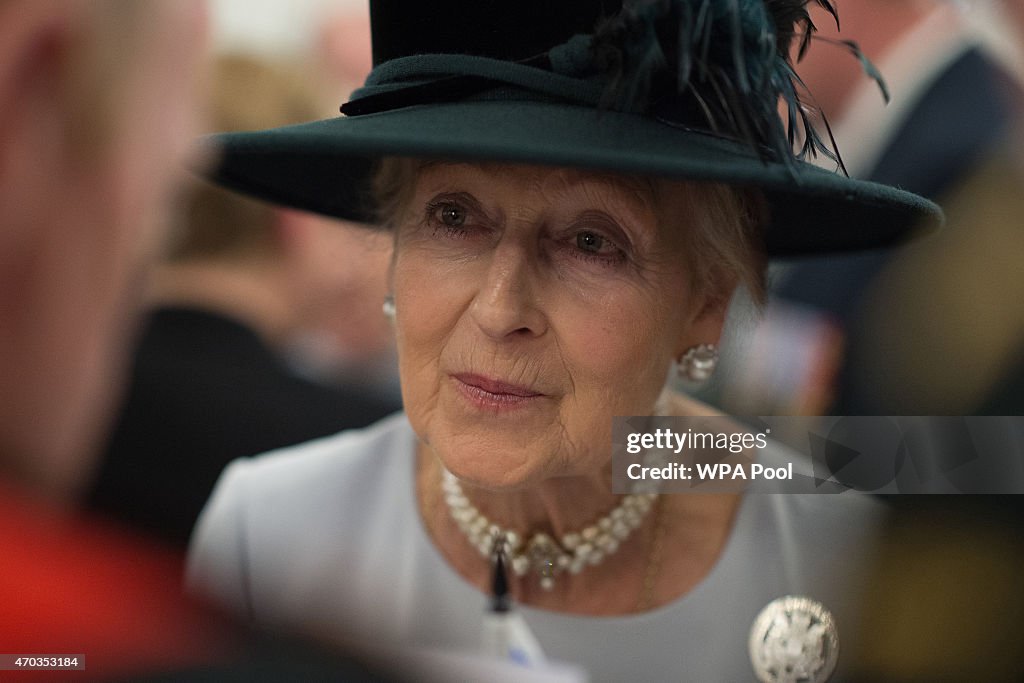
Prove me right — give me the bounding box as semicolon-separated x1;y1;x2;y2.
358;0;842;170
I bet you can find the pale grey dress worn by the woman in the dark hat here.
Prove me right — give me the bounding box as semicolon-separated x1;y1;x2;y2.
188;414;884;683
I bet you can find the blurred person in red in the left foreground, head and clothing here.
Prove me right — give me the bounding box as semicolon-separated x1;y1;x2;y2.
0;0;235;680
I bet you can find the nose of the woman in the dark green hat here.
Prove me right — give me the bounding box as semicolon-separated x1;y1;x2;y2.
470;242;547;340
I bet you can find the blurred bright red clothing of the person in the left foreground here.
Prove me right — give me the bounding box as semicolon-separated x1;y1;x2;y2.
0;487;232;681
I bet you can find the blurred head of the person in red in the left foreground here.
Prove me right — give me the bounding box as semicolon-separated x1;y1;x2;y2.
0;0;206;498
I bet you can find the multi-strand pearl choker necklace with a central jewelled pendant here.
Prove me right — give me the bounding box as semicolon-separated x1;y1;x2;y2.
441;470;657;591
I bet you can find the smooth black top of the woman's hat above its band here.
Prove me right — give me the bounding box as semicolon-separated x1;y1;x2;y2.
370;0;622;67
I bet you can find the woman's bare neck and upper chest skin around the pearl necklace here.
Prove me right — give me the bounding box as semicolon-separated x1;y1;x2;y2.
417;423;739;615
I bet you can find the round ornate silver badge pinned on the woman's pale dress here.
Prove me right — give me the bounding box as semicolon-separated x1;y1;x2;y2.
750;595;839;683
